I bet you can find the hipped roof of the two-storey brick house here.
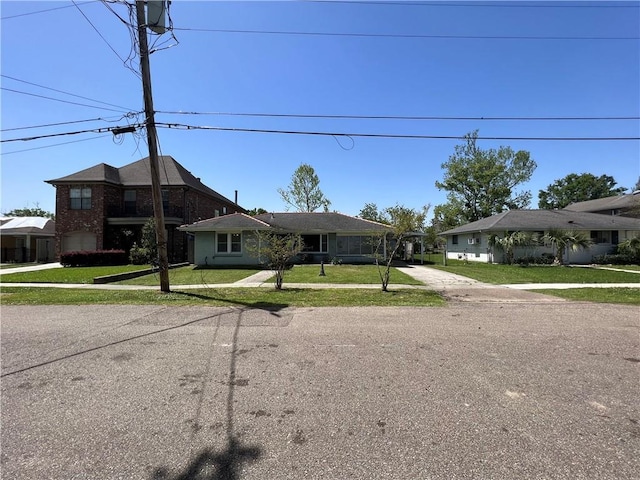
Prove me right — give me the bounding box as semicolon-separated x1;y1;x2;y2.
46;155;244;210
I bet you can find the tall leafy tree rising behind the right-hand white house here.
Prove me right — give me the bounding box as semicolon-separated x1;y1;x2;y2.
436;130;536;222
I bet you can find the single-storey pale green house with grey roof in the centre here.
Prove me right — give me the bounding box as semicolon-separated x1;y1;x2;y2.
178;212;391;265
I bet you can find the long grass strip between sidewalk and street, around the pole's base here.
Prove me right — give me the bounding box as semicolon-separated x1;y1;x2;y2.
0;284;445;308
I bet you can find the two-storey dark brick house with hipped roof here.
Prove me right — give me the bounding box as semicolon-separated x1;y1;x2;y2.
47;156;245;262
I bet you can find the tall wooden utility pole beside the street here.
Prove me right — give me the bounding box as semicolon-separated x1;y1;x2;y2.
136;0;170;293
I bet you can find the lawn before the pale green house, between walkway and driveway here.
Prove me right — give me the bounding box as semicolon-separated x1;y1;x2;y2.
284;265;422;285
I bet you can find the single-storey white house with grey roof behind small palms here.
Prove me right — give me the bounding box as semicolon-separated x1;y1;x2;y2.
440;210;640;264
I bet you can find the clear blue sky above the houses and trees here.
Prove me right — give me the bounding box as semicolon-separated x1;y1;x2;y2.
0;0;640;219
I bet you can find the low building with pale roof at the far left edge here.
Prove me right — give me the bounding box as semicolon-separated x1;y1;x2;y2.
0;217;56;263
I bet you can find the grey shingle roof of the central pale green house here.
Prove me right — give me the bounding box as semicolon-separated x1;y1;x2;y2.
179;212;391;234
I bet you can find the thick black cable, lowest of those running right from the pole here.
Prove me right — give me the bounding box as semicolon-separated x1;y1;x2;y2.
156;122;640;141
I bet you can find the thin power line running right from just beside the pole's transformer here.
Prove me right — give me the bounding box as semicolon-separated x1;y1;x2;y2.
173;27;640;40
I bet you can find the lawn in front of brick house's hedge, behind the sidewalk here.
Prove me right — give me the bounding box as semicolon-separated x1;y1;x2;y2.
0;265;149;283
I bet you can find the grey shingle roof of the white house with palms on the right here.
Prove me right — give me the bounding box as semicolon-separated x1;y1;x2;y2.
440;210;640;235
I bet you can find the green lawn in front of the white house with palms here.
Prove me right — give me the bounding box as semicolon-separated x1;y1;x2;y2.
430;260;640;285
